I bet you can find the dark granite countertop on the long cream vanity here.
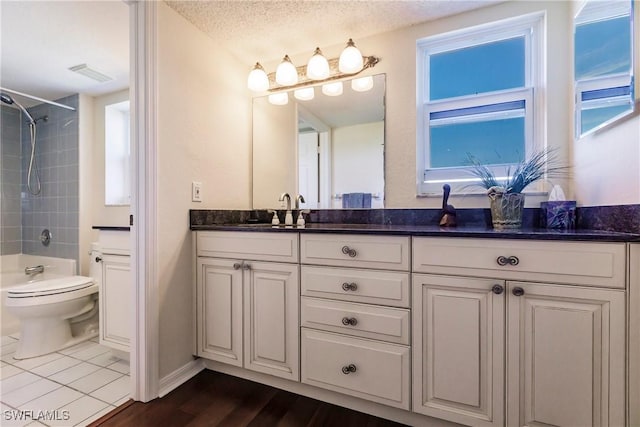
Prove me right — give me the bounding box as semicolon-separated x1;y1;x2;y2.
191;223;640;242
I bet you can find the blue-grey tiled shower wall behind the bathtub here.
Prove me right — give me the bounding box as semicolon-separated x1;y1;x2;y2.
2;95;79;268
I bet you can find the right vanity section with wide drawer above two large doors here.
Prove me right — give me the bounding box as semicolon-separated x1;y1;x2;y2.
412;237;626;426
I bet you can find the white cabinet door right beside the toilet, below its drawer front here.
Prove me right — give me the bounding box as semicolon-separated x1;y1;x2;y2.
99;255;133;352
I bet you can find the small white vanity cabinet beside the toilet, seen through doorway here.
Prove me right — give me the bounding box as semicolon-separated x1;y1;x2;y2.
91;230;133;352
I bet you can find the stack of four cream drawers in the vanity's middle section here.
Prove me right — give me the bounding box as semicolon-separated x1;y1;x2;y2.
300;234;411;409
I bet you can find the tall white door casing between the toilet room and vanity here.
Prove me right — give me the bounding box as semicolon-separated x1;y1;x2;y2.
128;1;159;402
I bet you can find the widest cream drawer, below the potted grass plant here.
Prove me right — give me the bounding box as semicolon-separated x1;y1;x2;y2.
413;237;626;288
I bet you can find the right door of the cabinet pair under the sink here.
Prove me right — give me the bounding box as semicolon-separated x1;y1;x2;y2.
244;261;300;381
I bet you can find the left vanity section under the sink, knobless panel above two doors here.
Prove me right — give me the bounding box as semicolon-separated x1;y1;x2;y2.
196;231;300;381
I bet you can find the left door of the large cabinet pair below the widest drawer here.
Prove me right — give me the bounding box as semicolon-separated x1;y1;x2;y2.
413;274;505;426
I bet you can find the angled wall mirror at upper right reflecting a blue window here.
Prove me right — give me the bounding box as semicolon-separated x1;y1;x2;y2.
574;0;634;137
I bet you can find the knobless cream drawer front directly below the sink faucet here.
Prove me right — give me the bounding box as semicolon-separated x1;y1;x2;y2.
196;231;298;262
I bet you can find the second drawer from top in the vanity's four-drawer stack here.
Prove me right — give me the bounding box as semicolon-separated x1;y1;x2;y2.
301;265;410;307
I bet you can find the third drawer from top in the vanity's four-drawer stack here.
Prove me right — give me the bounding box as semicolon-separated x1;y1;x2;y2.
301;297;409;345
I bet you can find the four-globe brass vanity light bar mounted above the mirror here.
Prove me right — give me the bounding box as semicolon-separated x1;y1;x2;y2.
247;39;380;92
